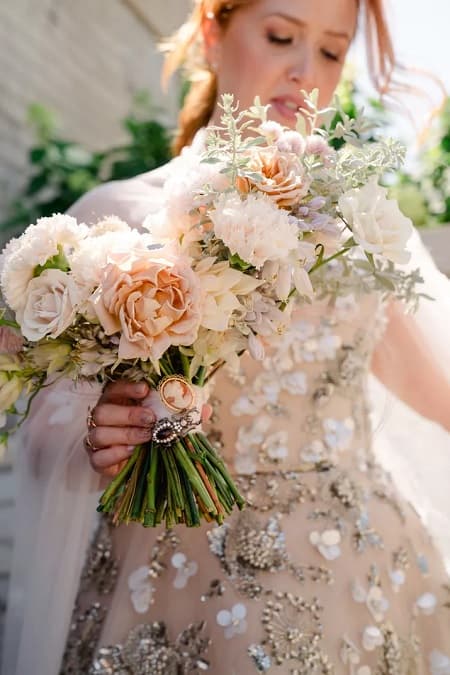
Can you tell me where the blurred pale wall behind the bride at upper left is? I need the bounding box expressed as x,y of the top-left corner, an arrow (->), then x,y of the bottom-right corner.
0,0 -> 189,220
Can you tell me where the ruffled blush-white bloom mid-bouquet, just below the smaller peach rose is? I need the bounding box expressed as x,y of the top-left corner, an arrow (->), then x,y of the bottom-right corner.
210,192 -> 298,269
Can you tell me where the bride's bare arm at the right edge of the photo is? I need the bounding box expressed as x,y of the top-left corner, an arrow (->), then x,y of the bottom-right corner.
372,302 -> 450,431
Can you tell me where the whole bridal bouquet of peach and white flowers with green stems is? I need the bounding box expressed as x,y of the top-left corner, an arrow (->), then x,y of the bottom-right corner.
0,93 -> 420,527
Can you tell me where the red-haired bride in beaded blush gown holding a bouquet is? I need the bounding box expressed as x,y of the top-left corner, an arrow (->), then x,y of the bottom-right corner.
2,0 -> 450,675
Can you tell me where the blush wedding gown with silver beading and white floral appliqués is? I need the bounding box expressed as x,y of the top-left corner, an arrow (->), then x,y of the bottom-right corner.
2,154 -> 450,675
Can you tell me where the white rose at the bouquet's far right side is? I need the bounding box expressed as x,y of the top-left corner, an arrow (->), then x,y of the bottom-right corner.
339,177 -> 413,263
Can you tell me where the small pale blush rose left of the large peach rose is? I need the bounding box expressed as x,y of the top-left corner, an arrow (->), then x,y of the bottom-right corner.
16,269 -> 87,341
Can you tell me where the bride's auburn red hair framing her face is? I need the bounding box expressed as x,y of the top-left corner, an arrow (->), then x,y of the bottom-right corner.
162,0 -> 396,154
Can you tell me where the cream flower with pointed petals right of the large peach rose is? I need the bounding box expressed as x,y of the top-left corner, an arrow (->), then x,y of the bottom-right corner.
195,258 -> 261,332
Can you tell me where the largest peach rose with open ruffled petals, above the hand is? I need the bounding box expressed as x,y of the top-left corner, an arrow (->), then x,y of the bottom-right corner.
91,251 -> 201,363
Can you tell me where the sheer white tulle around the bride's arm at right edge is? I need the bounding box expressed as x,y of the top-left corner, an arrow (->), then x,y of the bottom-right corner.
370,227 -> 450,570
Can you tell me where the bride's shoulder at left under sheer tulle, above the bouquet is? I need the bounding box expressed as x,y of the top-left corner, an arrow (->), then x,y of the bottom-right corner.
68,162 -> 170,227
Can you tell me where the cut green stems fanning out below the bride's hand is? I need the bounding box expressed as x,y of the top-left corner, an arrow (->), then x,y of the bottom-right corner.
97,418 -> 245,528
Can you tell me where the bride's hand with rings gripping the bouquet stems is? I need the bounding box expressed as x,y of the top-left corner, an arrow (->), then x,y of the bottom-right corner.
84,381 -> 155,477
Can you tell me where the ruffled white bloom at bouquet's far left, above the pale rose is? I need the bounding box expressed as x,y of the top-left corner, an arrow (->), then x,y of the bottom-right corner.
0,214 -> 88,311
